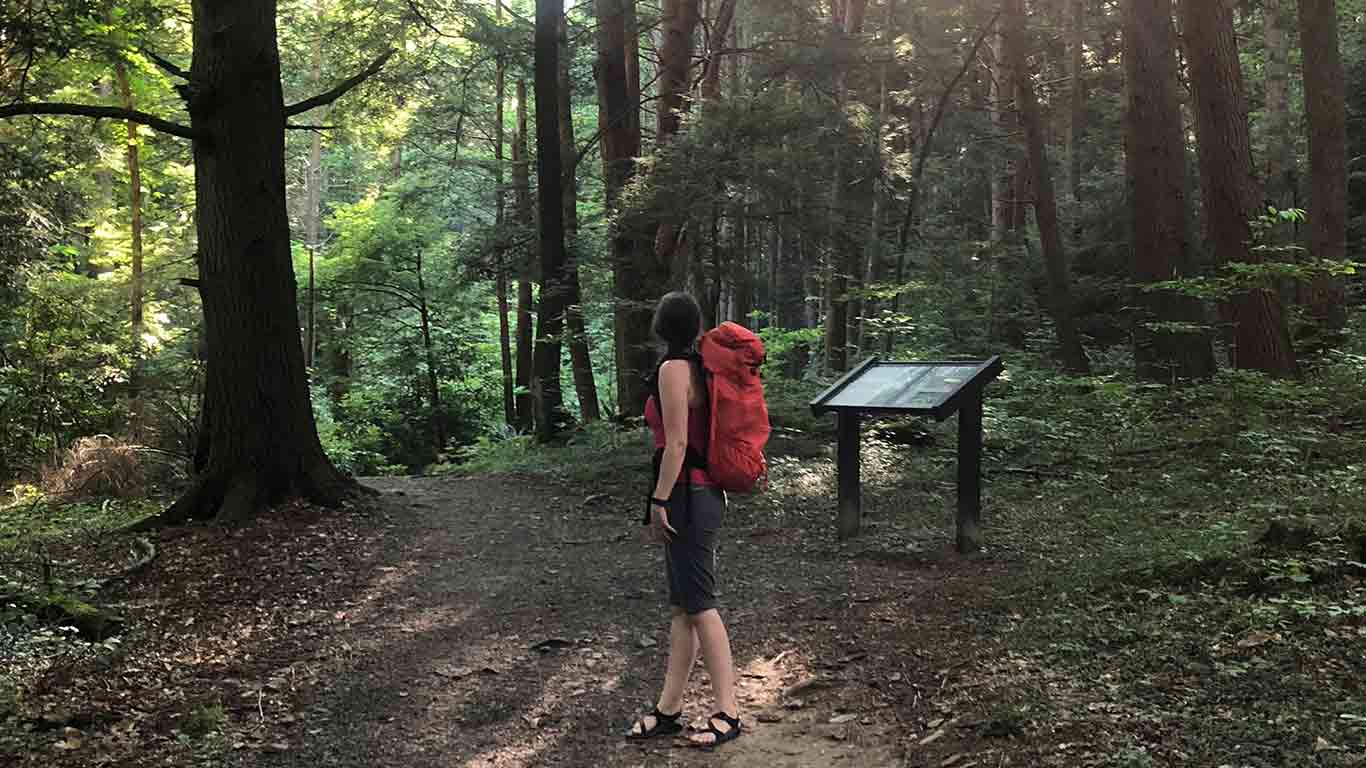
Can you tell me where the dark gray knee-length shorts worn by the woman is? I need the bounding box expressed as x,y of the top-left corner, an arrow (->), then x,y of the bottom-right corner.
664,485 -> 725,615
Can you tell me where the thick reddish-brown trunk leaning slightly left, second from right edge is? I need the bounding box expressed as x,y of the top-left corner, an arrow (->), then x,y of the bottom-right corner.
1180,0 -> 1298,376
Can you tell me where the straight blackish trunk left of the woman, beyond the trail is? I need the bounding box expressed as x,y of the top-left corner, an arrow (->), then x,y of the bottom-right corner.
535,0 -> 570,441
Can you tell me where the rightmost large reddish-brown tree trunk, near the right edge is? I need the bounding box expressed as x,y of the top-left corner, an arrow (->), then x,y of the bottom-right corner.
1299,0 -> 1348,331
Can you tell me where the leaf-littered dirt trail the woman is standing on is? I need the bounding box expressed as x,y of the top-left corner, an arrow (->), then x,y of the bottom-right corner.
224,478 -> 988,768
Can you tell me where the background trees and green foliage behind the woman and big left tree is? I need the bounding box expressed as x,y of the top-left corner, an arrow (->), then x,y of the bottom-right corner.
0,0 -> 1366,484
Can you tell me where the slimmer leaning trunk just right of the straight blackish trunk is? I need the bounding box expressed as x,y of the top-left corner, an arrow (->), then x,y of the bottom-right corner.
557,10 -> 602,422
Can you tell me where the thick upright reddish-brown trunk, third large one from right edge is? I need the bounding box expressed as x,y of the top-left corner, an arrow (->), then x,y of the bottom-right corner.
1124,0 -> 1214,381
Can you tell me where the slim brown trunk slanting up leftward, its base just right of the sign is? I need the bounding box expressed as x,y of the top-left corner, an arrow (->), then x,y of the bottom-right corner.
1005,0 -> 1090,373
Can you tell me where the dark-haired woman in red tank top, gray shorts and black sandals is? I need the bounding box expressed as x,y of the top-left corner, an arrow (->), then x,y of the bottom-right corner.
627,292 -> 740,746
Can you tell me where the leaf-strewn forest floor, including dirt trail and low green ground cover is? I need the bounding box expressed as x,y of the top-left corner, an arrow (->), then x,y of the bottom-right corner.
0,358 -> 1366,768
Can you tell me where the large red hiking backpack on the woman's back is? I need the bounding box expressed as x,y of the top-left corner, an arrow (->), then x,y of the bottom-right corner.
699,323 -> 769,493
